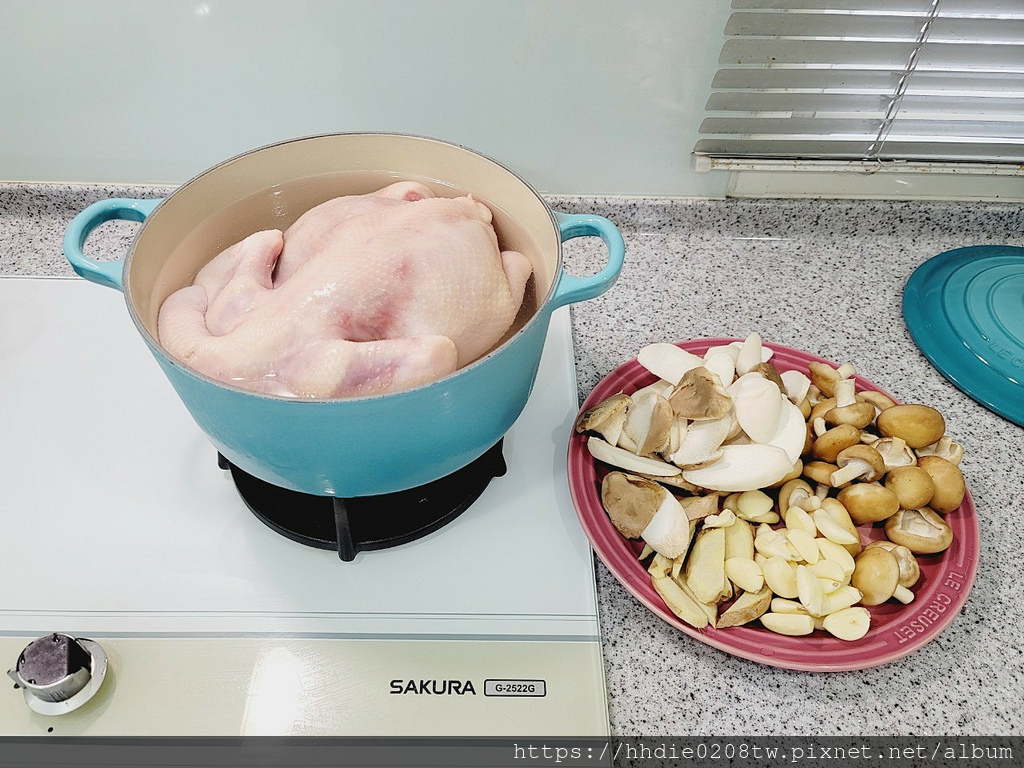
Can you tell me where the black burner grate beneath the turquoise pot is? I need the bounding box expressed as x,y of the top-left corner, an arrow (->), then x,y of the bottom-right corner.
217,441 -> 505,562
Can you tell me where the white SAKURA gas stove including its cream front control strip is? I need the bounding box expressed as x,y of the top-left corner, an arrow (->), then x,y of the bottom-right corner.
0,278 -> 608,736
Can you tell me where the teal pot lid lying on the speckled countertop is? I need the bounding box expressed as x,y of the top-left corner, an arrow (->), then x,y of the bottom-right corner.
903,246 -> 1024,425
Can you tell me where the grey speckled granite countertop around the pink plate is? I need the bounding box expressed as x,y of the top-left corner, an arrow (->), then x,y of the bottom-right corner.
0,184 -> 1024,735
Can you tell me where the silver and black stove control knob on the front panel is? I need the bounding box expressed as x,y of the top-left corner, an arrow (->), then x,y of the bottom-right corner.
7,632 -> 106,715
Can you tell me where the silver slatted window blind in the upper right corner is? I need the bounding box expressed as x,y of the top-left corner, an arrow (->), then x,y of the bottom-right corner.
694,0 -> 1024,172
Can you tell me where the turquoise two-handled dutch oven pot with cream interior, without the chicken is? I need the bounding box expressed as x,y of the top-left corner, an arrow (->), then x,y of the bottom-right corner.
65,133 -> 625,498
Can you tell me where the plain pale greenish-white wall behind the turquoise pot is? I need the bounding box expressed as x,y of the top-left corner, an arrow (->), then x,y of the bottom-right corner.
0,0 -> 729,197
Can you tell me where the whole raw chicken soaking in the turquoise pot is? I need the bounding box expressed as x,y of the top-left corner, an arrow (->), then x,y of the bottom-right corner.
158,181 -> 532,397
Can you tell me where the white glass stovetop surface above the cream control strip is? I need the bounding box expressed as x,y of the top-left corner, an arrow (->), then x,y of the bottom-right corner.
0,278 -> 598,639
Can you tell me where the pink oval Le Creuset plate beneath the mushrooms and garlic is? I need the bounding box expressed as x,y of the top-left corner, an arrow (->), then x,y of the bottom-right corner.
568,339 -> 981,672
